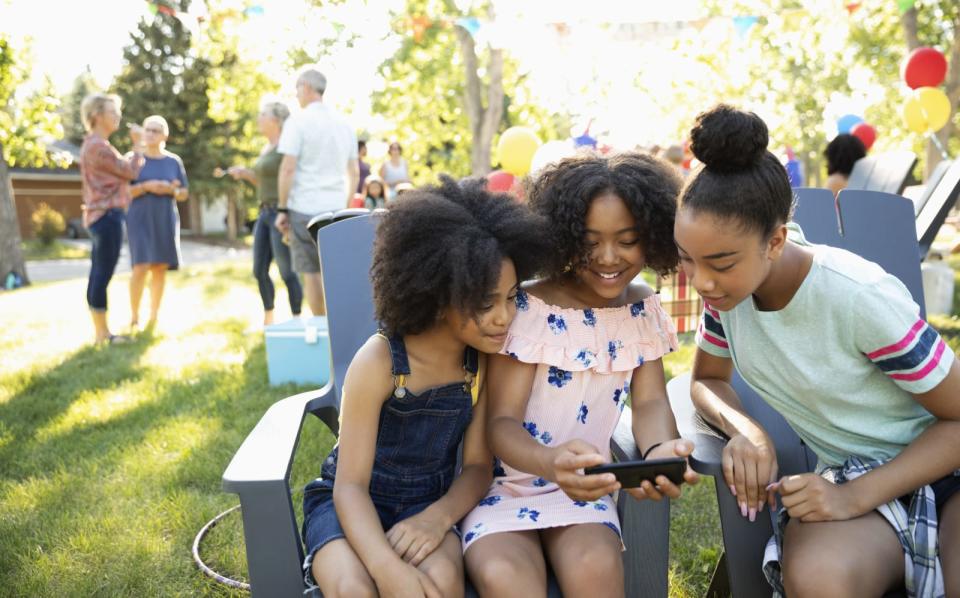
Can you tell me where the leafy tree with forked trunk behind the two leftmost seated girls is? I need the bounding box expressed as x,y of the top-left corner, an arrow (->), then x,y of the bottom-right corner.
373,0 -> 567,182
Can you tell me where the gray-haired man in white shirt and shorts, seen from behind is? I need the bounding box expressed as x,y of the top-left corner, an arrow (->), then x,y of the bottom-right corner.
276,68 -> 360,316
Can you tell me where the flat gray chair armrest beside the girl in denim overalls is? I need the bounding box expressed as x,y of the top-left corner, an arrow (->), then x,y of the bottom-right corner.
223,383 -> 336,494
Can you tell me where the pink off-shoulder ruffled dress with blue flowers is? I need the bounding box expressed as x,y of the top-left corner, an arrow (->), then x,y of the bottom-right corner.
461,291 -> 677,551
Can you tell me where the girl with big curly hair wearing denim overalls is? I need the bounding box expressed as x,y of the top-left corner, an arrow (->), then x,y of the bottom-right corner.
303,177 -> 546,598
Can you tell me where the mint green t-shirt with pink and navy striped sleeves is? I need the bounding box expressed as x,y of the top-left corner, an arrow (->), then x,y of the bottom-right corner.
696,225 -> 954,466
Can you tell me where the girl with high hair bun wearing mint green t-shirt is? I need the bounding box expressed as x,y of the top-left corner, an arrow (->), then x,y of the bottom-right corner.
675,105 -> 960,598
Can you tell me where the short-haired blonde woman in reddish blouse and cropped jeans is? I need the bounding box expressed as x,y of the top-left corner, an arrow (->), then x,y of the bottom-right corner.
80,93 -> 144,343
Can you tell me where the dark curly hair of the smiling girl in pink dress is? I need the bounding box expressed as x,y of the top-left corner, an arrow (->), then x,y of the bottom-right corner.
527,152 -> 681,277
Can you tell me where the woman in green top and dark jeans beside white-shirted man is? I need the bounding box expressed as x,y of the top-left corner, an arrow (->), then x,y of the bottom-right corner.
227,102 -> 303,326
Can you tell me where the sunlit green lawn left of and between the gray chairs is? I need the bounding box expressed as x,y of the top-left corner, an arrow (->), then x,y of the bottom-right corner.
0,263 -> 720,597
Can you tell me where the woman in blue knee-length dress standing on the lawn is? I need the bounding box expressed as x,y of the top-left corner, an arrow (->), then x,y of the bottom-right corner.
127,115 -> 189,330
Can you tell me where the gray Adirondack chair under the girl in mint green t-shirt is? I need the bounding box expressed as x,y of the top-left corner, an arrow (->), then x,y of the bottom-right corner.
667,189 -> 924,598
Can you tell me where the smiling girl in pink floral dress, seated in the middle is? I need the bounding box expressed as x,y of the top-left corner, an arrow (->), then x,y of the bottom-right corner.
461,153 -> 696,597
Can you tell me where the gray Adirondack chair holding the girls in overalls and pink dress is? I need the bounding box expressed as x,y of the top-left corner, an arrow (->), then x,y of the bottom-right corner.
223,209 -> 670,598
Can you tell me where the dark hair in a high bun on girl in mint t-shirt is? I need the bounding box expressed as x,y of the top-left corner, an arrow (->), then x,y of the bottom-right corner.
680,104 -> 793,238
